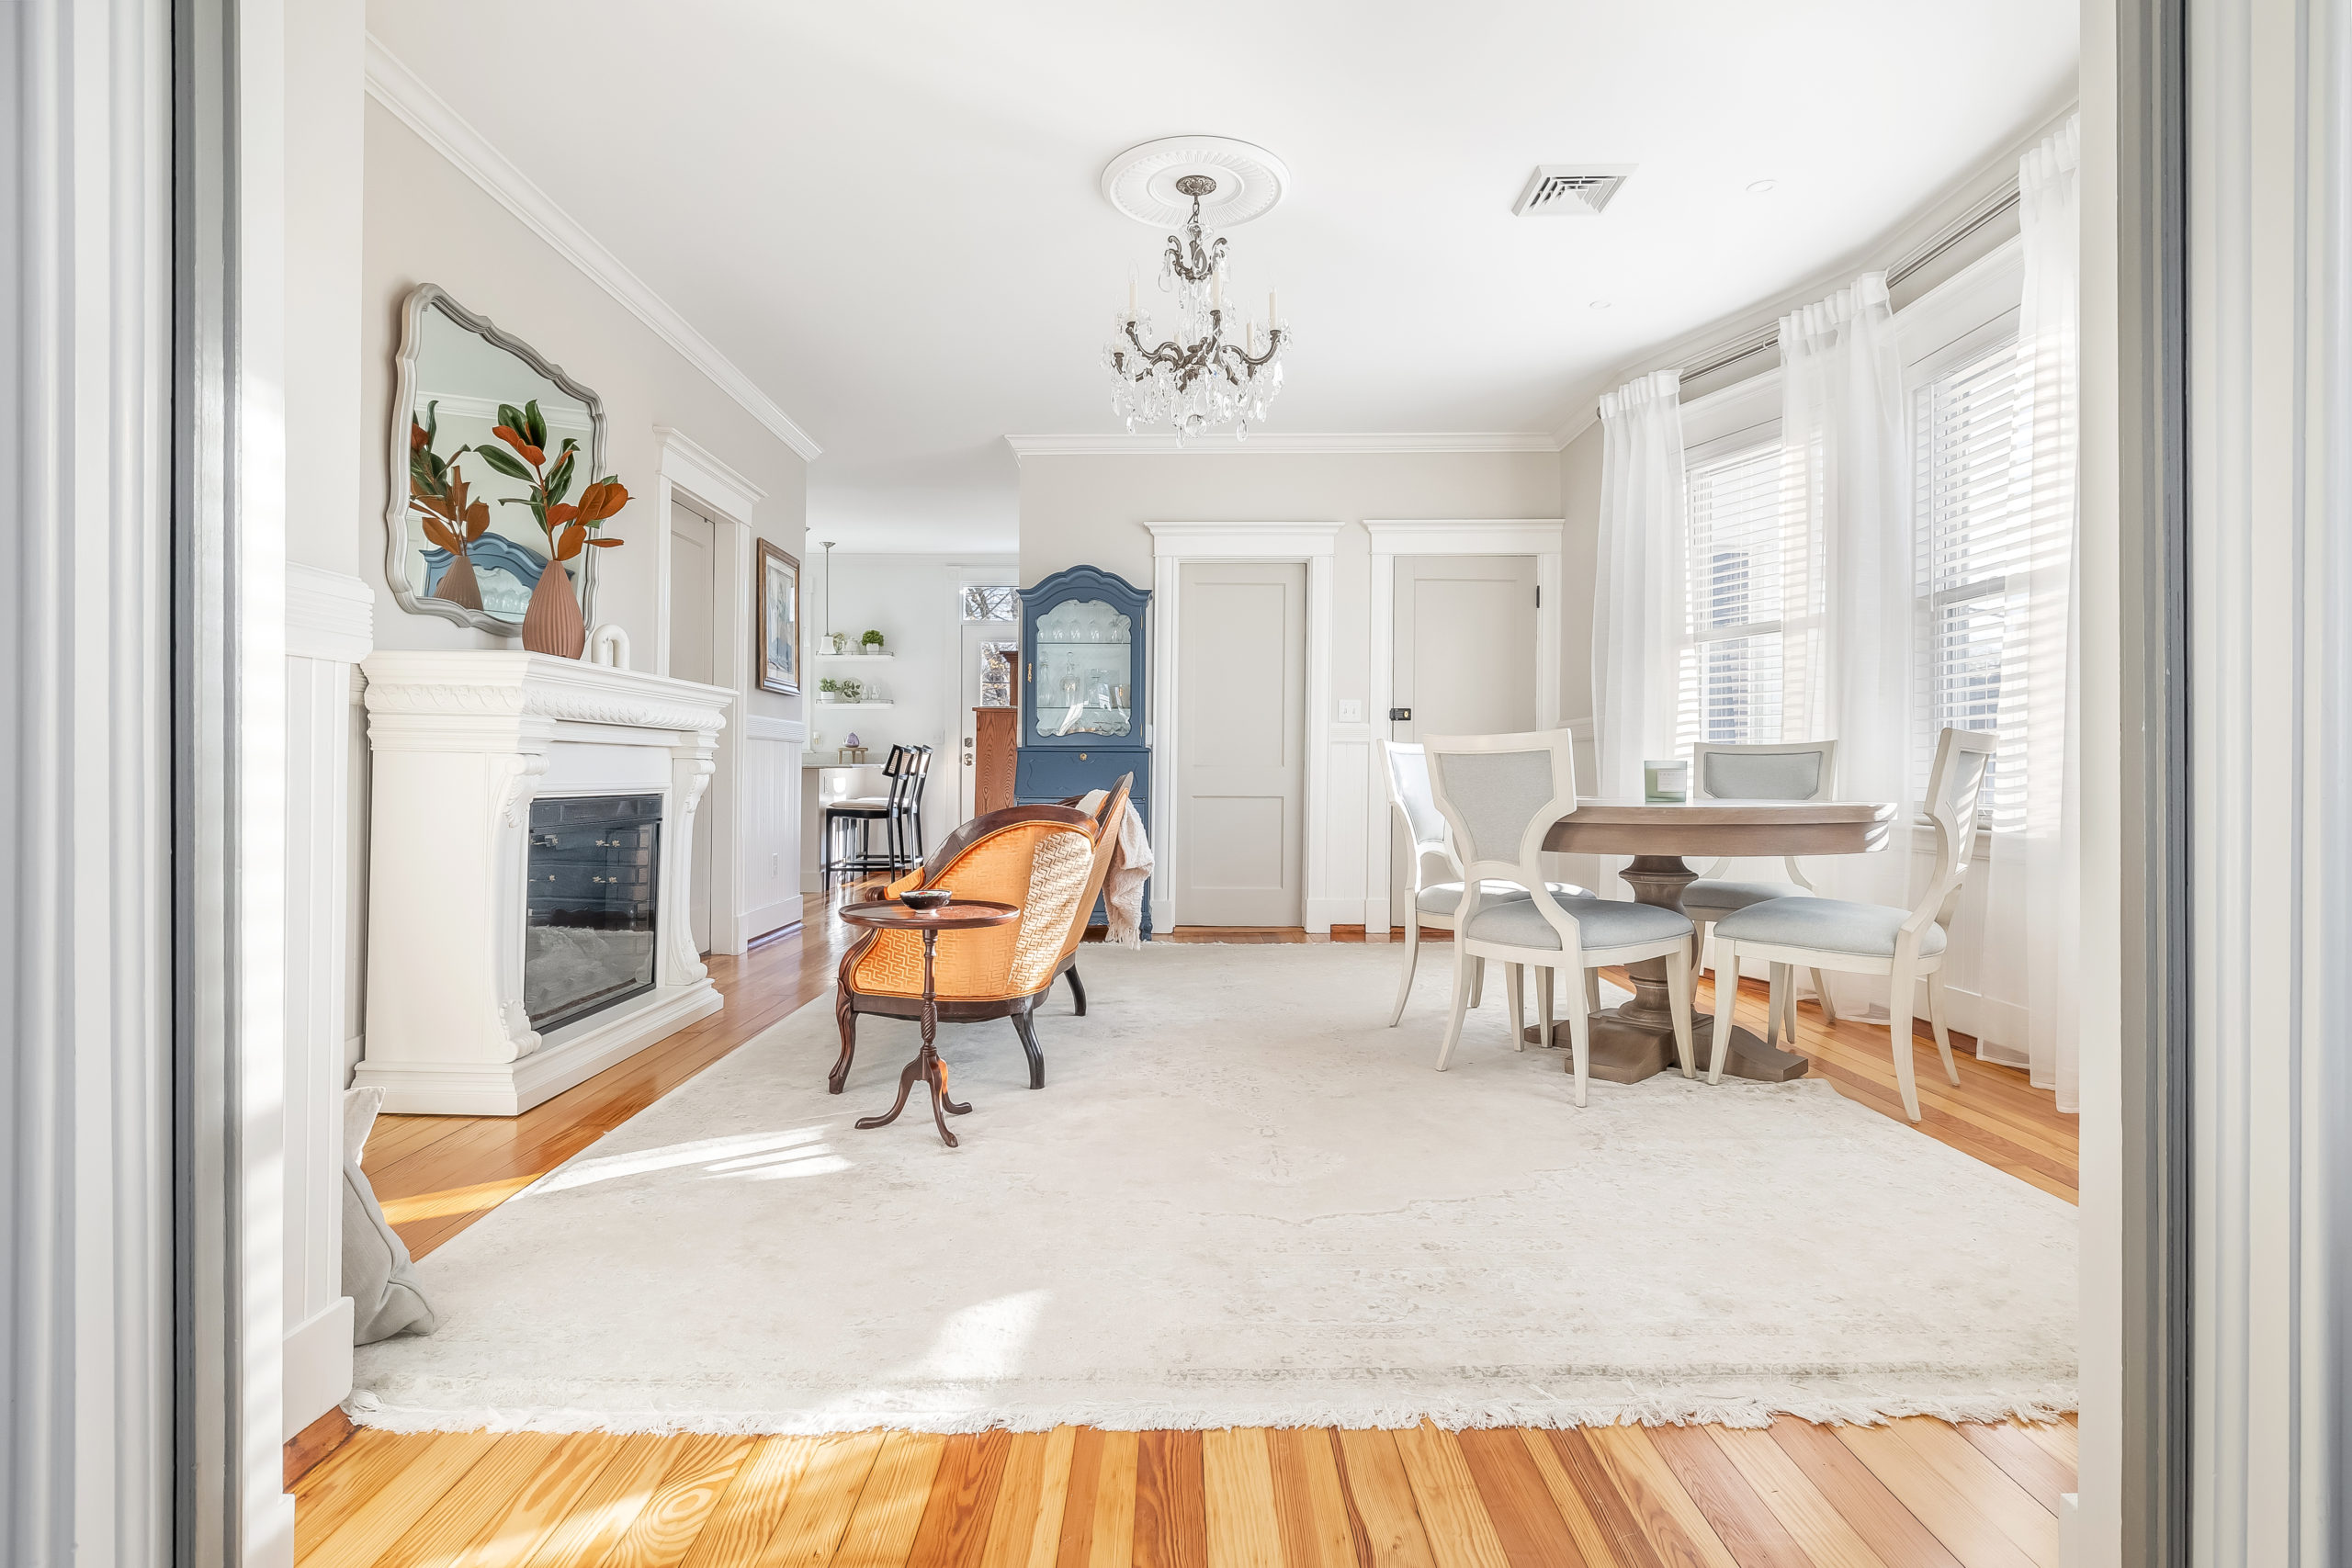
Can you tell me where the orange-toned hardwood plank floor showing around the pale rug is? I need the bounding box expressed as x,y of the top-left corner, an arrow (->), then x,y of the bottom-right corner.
326,900 -> 2076,1568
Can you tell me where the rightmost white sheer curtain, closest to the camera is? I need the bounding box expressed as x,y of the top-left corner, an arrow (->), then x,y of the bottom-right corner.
1978,120 -> 2082,1112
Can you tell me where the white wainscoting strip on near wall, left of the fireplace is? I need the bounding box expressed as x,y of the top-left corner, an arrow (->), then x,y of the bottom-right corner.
285,564 -> 377,1437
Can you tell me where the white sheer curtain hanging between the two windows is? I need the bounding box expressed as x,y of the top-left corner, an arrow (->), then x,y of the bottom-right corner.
1781,273 -> 1917,1016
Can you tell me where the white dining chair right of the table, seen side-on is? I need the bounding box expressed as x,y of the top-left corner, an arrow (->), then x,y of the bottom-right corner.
1708,728 -> 1996,1122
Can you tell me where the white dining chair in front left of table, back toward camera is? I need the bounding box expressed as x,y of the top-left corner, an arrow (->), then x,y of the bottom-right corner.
1423,728 -> 1696,1105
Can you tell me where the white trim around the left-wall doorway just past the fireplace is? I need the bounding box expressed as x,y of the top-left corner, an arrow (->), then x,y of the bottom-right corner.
651,425 -> 767,952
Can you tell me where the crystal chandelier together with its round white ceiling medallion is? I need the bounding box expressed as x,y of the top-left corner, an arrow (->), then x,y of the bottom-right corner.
1103,136 -> 1291,445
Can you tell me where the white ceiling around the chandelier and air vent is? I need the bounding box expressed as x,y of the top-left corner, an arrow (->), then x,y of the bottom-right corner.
369,0 -> 2075,550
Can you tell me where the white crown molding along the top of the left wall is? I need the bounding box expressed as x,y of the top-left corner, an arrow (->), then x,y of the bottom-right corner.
367,33 -> 823,463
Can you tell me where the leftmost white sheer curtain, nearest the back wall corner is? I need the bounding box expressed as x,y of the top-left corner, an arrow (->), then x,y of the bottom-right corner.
1578,369 -> 1691,799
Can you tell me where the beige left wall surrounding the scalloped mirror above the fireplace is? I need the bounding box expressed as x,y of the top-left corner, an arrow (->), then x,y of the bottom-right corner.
357,101 -> 809,717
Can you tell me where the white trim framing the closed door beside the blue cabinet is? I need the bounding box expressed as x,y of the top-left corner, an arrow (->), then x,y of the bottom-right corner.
1143,520 -> 1345,931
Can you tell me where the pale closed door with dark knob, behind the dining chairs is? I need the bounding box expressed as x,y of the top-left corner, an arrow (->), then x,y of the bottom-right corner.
1387,555 -> 1536,919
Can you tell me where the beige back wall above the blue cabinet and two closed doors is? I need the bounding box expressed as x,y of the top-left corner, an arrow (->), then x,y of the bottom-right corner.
1021,451 -> 1571,715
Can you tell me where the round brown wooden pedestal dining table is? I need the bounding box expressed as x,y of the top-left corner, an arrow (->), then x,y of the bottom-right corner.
1536,799 -> 1895,1084
